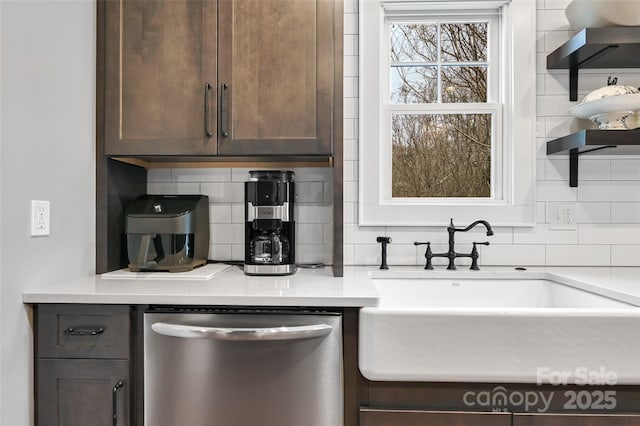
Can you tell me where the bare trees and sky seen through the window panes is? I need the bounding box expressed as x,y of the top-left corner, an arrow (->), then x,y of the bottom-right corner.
390,22 -> 494,198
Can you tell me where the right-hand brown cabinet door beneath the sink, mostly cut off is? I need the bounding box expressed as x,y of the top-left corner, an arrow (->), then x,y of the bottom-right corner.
513,413 -> 640,426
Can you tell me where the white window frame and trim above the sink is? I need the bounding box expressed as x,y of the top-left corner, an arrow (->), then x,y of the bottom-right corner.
358,0 -> 536,226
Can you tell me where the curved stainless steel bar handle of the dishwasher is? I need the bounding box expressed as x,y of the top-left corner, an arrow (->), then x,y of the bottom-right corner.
151,322 -> 333,342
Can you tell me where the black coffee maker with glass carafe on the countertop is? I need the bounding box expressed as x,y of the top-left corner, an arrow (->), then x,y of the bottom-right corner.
244,170 -> 296,275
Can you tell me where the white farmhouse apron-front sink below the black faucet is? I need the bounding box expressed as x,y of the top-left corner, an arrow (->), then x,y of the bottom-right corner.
359,271 -> 640,384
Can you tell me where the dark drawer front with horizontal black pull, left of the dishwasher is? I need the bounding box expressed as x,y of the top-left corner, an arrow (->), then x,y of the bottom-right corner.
36,304 -> 130,359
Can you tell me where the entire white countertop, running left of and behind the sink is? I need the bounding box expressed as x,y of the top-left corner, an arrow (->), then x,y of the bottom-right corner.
22,266 -> 640,307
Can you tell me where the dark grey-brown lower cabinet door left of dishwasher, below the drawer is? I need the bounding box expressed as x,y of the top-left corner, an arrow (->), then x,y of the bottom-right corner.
36,359 -> 130,426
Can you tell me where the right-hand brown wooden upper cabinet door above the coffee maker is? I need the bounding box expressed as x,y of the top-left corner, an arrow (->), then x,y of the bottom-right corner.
218,0 -> 342,155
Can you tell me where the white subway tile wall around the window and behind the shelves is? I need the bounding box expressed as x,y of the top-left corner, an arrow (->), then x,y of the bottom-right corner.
344,0 -> 640,266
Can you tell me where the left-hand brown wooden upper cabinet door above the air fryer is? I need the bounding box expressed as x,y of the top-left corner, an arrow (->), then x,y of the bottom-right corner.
102,0 -> 217,155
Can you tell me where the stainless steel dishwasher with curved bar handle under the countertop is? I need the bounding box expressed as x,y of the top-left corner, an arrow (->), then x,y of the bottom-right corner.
144,307 -> 343,426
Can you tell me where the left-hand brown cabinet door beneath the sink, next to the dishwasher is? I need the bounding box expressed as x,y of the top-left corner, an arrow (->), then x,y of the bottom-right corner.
360,408 -> 511,426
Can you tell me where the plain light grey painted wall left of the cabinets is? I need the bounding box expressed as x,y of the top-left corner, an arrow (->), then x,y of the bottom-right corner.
0,0 -> 96,426
